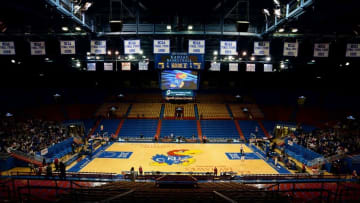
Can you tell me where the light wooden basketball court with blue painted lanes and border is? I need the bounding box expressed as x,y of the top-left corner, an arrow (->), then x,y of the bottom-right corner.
68,143 -> 290,175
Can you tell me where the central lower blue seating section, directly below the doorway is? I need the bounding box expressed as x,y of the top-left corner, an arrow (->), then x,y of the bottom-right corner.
160,120 -> 198,139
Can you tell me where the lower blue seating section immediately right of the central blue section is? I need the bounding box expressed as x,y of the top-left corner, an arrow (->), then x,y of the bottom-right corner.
201,120 -> 240,139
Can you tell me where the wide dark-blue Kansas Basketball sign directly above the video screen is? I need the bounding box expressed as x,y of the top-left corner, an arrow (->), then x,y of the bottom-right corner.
155,53 -> 204,70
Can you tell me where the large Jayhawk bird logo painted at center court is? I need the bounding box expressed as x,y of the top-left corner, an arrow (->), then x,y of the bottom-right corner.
151,149 -> 201,166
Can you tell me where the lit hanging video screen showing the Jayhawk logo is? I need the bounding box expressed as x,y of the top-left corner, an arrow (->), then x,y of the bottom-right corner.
161,70 -> 198,90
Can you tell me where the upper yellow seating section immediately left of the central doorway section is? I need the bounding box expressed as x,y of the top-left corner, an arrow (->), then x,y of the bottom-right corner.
128,103 -> 161,119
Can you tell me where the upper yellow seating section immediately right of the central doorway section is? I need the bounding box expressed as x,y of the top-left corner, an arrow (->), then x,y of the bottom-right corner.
197,104 -> 230,119
